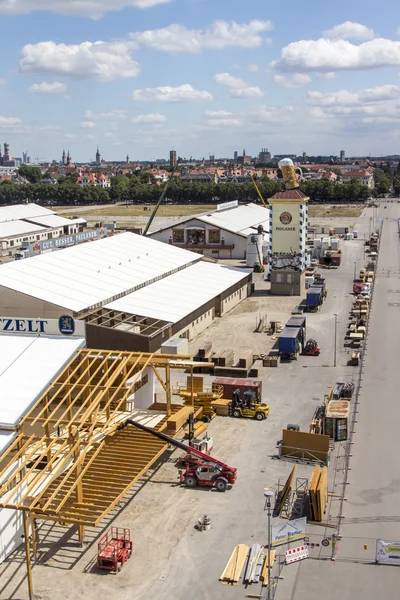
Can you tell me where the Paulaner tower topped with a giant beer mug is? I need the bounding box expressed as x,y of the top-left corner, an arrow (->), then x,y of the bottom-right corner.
269,158 -> 309,296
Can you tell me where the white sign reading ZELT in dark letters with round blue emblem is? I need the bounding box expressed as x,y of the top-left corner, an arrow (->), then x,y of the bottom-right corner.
0,315 -> 86,337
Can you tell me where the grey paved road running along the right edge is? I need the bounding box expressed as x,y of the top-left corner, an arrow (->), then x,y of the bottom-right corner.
277,202 -> 400,600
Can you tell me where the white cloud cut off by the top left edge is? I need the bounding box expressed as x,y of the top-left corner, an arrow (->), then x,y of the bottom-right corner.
0,0 -> 173,19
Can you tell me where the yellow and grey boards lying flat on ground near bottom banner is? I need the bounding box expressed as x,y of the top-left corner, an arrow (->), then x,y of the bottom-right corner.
219,544 -> 276,585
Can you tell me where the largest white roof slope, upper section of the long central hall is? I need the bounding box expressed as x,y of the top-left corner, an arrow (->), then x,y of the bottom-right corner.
0,233 -> 201,312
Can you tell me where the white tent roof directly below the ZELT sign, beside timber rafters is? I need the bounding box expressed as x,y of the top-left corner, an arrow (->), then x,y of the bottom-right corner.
0,334 -> 85,428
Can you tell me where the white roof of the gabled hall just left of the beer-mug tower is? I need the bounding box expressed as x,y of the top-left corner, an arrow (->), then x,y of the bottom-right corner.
194,204 -> 269,236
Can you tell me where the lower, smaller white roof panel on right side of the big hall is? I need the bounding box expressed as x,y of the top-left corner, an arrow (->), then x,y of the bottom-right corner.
105,261 -> 250,323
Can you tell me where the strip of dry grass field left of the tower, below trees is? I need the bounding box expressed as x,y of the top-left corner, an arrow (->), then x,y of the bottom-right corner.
57,204 -> 216,220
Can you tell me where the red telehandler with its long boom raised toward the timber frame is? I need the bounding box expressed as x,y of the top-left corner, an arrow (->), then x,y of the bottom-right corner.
117,419 -> 237,492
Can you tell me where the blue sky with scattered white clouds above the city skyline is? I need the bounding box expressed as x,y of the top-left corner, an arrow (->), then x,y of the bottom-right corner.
0,0 -> 400,161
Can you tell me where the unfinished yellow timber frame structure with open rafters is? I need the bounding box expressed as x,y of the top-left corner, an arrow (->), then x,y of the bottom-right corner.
0,349 -> 209,598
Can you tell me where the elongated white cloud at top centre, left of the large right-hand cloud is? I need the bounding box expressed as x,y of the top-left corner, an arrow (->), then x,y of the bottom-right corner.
130,19 -> 272,53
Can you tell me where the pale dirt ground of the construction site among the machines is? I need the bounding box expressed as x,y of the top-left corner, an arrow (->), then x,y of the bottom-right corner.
0,211 -> 368,600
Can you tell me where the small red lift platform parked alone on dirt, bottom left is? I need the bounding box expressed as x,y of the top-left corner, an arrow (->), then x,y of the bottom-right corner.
97,527 -> 132,572
